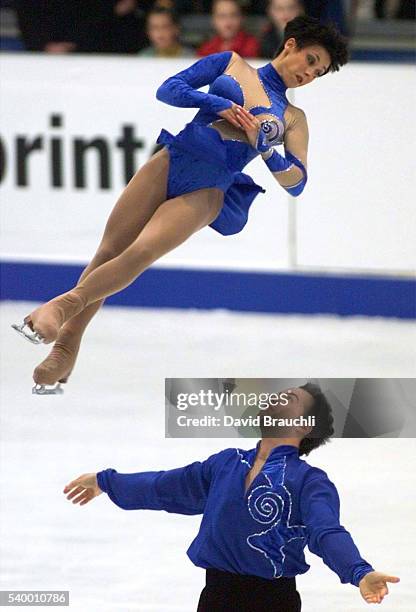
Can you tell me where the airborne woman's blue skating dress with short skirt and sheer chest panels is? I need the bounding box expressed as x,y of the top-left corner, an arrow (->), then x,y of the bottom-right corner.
156,51 -> 303,235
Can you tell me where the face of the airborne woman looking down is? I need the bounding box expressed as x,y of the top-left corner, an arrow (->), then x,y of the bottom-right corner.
279,38 -> 331,87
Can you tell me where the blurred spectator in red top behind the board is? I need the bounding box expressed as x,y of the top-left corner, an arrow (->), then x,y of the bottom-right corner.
198,0 -> 260,57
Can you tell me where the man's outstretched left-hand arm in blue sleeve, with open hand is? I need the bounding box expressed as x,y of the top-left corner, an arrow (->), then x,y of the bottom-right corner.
64,455 -> 216,514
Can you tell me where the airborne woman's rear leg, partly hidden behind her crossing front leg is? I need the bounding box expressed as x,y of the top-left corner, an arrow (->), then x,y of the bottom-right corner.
33,150 -> 169,385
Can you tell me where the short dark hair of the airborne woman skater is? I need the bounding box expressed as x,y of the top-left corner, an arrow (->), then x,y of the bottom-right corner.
276,15 -> 348,72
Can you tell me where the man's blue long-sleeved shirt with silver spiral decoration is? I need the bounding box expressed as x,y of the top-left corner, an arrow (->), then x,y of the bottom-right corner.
97,445 -> 373,586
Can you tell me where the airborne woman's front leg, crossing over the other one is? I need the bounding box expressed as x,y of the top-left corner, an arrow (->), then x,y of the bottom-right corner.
30,188 -> 223,340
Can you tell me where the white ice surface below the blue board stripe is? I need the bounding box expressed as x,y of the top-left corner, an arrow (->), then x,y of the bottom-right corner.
0,302 -> 416,612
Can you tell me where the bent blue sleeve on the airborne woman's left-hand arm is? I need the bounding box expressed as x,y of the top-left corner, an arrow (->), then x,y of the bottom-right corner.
156,51 -> 233,113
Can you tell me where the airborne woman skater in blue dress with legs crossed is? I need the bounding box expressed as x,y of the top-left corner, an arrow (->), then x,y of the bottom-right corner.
13,17 -> 348,392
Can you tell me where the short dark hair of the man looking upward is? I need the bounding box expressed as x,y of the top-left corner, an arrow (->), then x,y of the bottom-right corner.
299,383 -> 334,455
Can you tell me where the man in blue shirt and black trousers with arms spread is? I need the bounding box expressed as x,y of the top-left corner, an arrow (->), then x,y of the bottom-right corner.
64,383 -> 399,612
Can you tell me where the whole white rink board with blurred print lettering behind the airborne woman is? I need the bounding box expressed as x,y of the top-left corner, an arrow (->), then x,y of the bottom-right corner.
0,54 -> 416,272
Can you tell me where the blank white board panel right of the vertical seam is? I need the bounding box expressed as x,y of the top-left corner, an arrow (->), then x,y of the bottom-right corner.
296,64 -> 416,270
